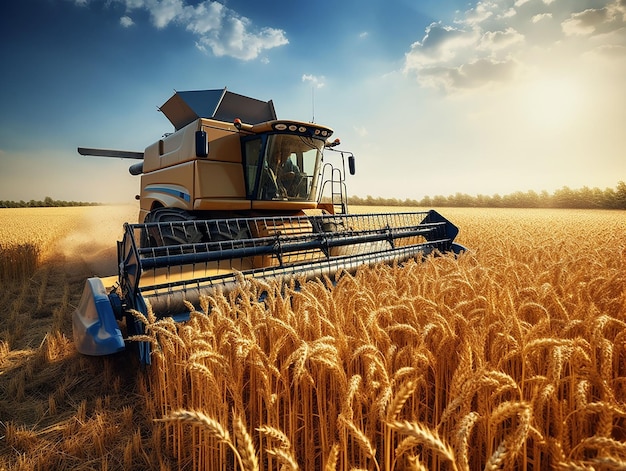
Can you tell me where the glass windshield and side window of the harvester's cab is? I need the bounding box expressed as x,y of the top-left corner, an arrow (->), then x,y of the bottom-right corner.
246,134 -> 324,200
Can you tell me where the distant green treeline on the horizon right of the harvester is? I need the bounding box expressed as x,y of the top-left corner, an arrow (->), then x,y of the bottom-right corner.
349,181 -> 626,209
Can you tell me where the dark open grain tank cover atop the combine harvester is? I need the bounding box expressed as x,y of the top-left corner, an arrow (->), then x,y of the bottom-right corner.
160,88 -> 276,131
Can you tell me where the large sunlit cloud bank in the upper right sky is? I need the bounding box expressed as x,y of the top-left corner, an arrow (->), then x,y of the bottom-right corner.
404,0 -> 626,92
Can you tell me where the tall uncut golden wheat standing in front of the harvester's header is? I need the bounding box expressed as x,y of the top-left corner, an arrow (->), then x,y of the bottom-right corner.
138,211 -> 626,469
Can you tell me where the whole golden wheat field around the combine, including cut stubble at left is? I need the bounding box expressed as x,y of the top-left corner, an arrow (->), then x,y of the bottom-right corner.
0,208 -> 626,470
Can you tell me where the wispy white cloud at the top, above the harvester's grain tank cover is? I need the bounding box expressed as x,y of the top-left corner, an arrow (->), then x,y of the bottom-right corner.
74,0 -> 289,60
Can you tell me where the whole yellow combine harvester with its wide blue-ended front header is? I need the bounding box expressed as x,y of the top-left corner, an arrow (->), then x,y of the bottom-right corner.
73,89 -> 464,363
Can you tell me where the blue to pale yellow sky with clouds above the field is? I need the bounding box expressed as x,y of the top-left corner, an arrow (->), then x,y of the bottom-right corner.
0,0 -> 626,203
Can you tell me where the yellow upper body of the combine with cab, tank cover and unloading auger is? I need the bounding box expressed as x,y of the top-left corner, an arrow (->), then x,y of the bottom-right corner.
78,89 -> 352,227
